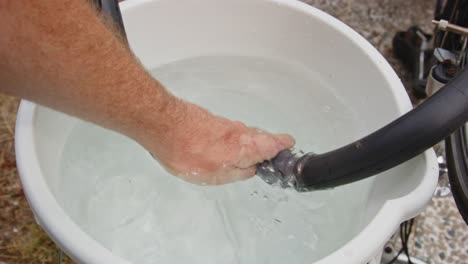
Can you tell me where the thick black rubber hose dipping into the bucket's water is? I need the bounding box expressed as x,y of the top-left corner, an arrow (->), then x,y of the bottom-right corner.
294,70 -> 468,190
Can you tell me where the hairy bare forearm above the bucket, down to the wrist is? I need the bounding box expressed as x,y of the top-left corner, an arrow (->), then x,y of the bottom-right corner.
0,0 -> 176,142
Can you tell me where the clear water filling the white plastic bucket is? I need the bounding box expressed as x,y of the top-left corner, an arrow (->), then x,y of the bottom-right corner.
59,56 -> 370,264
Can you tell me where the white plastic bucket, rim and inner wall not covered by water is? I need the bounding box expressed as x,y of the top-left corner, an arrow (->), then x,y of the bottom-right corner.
16,0 -> 438,263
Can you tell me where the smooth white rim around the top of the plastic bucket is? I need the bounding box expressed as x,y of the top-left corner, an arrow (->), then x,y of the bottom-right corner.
15,0 -> 438,264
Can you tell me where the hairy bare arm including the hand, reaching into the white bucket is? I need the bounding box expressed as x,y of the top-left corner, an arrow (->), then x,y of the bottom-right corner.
0,0 -> 294,184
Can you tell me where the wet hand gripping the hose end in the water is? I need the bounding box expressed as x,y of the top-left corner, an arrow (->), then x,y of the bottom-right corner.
143,99 -> 294,185
